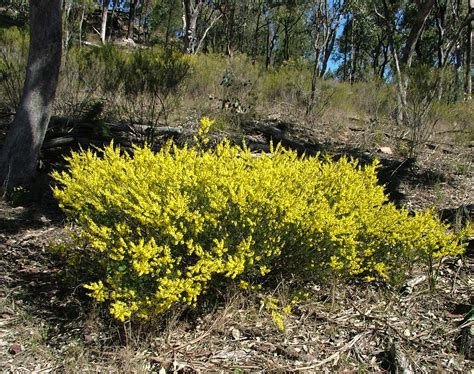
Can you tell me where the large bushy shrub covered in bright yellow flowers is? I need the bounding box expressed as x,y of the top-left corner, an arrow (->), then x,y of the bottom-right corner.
53,119 -> 463,321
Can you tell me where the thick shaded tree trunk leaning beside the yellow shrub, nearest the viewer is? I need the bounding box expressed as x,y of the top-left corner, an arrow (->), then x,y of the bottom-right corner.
0,0 -> 62,189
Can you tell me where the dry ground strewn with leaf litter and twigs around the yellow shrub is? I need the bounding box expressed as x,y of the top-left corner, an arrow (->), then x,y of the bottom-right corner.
0,116 -> 474,373
